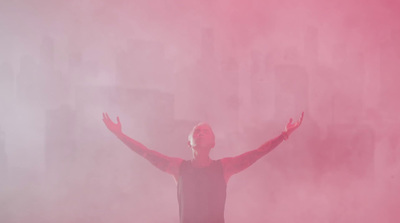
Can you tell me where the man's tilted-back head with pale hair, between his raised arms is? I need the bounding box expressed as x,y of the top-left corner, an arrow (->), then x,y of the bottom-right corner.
188,122 -> 215,151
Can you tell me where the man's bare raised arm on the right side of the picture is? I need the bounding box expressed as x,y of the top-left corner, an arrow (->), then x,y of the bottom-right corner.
221,112 -> 304,182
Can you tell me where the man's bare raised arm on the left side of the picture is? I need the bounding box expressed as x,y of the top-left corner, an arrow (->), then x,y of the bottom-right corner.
103,113 -> 183,179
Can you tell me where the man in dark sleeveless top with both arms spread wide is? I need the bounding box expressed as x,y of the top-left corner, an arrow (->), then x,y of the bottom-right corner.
103,113 -> 304,223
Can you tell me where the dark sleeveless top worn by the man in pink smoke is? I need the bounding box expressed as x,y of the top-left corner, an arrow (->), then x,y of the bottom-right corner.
178,160 -> 226,223
